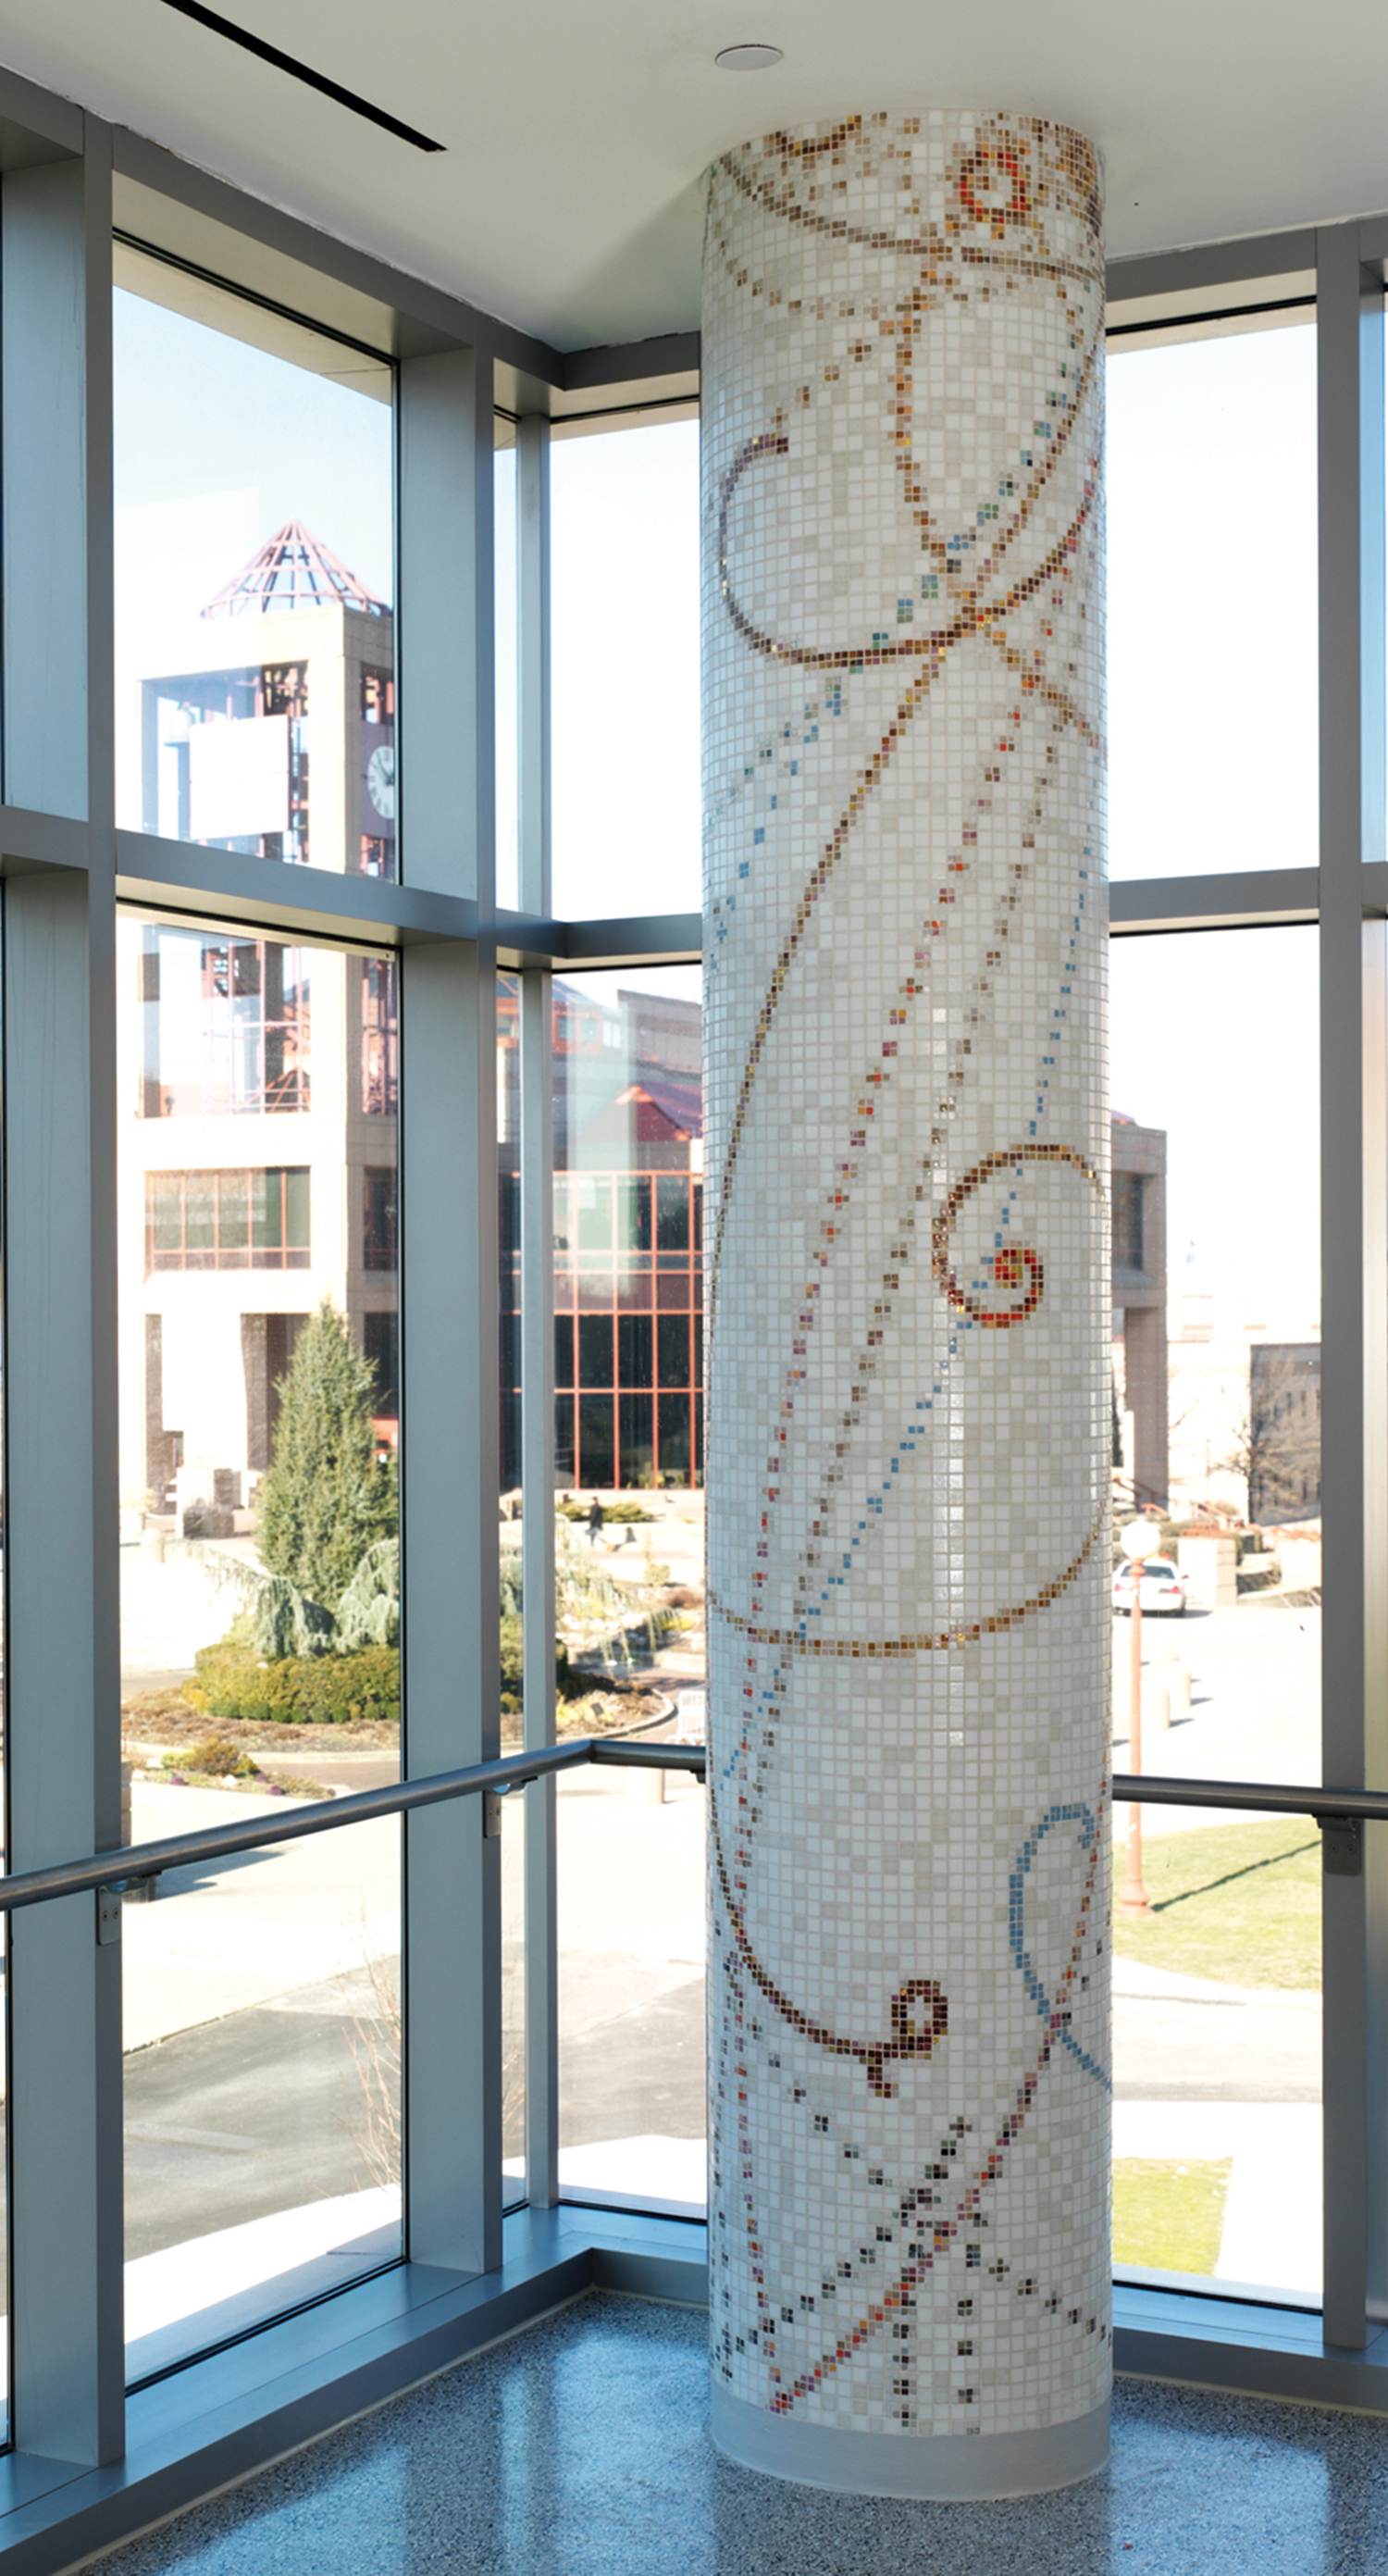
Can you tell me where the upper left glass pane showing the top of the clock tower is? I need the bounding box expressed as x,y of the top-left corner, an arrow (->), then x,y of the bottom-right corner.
113,244 -> 399,880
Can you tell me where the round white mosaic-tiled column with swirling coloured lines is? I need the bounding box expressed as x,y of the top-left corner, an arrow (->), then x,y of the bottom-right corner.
703,113 -> 1109,2496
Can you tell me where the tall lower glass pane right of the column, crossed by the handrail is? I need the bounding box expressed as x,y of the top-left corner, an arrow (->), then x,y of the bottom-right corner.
1112,930 -> 1321,2303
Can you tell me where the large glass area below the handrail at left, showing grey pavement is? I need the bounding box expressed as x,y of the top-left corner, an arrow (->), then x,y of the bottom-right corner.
121,1823 -> 402,2380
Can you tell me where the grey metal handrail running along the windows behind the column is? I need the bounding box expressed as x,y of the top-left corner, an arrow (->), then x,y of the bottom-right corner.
0,1736 -> 1388,1914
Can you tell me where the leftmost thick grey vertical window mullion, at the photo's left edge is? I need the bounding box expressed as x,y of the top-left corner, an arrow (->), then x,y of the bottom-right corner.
0,118 -> 124,2463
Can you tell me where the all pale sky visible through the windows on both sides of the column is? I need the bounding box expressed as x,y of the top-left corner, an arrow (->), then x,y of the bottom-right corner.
116,279 -> 1319,1337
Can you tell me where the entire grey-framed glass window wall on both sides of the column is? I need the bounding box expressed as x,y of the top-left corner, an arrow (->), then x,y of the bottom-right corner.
0,70 -> 1388,2545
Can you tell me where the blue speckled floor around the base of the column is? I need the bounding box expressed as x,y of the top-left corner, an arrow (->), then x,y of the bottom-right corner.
101,2297 -> 1388,2576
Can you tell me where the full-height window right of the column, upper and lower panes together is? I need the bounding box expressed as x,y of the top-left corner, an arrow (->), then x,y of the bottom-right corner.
1108,304 -> 1323,2303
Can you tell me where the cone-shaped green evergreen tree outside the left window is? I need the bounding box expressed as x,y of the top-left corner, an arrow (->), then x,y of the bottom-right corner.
257,1299 -> 399,1610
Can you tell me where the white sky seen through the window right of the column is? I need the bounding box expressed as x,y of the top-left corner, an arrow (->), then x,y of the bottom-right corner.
1108,325 -> 1321,1339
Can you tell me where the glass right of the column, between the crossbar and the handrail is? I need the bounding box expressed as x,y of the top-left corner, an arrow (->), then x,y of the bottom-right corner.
1112,930 -> 1321,1780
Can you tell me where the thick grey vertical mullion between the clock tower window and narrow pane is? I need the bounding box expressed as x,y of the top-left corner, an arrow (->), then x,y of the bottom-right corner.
399,350 -> 502,2274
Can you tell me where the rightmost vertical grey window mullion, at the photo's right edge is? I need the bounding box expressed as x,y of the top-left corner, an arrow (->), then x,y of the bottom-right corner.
1316,224 -> 1388,2346
